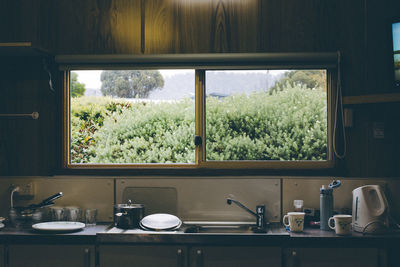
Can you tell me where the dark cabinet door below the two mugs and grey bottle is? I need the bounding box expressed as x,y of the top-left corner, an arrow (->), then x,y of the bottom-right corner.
285,248 -> 380,267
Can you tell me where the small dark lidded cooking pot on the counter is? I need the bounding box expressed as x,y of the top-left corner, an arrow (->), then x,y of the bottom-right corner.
114,200 -> 144,229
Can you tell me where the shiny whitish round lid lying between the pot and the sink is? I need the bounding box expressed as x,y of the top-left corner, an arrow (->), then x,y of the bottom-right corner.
140,213 -> 182,231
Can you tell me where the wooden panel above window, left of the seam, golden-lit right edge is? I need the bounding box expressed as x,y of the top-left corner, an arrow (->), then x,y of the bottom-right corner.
56,0 -> 141,54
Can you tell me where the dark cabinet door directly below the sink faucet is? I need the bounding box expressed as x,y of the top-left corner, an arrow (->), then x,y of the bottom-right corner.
190,246 -> 281,267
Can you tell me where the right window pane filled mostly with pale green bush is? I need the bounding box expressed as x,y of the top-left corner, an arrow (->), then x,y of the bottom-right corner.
206,70 -> 328,161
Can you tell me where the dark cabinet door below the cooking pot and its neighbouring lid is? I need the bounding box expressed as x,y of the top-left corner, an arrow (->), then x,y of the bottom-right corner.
99,245 -> 187,267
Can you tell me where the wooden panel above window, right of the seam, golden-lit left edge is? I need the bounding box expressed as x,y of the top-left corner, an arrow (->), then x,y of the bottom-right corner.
145,0 -> 259,54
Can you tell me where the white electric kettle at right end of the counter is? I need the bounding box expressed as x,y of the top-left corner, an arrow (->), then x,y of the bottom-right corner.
352,185 -> 389,233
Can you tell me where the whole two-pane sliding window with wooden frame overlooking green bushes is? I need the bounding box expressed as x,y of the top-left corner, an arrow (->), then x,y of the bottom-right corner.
61,53 -> 336,169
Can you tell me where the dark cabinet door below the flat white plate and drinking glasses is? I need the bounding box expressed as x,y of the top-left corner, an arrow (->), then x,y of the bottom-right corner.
8,245 -> 95,267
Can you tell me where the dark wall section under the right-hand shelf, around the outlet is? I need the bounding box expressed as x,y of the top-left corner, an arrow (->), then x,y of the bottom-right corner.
345,103 -> 400,177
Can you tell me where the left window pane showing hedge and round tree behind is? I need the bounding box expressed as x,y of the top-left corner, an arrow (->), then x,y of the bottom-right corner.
70,70 -> 195,164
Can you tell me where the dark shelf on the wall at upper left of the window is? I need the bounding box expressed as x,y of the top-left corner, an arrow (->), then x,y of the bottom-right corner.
0,42 -> 49,57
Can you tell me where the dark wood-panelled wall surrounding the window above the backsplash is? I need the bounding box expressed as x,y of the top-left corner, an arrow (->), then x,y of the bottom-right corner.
0,0 -> 400,177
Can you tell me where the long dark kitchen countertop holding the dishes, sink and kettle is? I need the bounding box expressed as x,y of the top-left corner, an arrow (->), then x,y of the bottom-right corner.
0,225 -> 400,247
